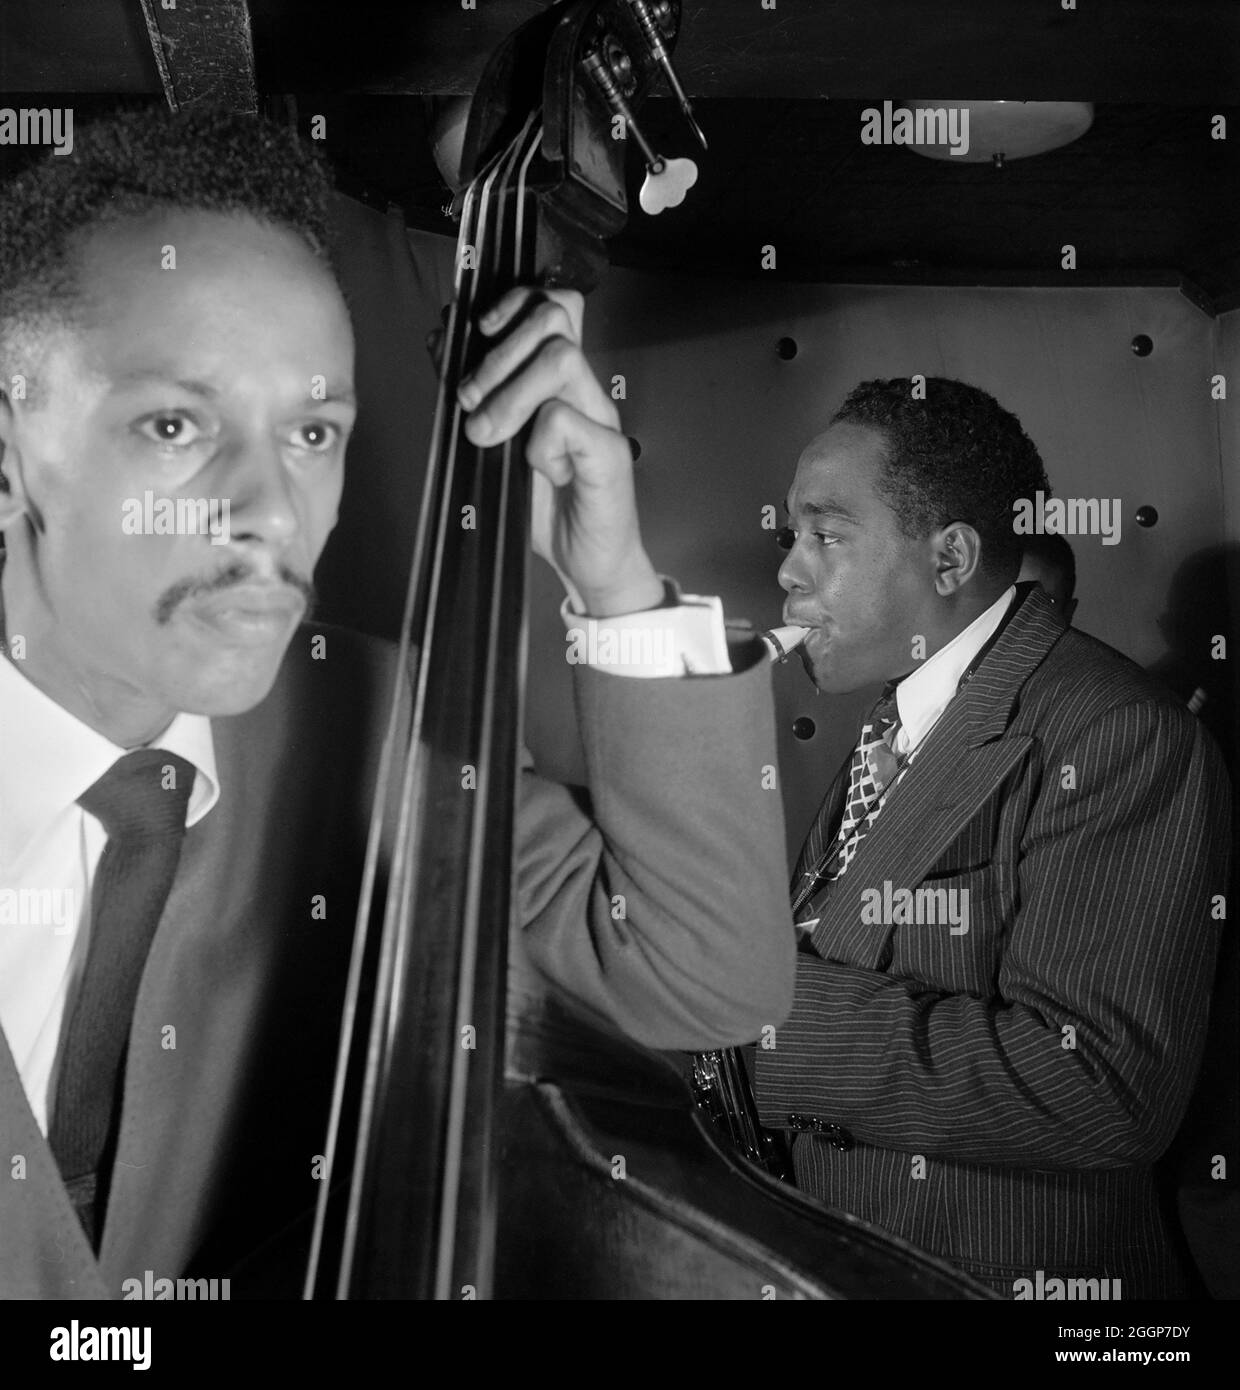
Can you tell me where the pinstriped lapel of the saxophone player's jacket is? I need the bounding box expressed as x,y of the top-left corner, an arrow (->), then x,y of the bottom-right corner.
806,589 -> 1063,969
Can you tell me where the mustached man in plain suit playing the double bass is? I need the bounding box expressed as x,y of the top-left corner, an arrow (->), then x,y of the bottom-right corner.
0,113 -> 792,1298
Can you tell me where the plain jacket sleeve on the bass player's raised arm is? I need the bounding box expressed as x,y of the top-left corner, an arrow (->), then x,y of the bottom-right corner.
517,636 -> 794,1049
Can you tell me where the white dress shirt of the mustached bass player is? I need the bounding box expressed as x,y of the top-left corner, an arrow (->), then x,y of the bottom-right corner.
0,657 -> 220,1134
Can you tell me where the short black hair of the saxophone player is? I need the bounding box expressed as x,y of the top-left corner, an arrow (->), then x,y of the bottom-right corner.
831,377 -> 1051,582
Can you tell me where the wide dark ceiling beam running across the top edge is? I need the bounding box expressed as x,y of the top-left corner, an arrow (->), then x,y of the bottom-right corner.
0,0 -> 1240,106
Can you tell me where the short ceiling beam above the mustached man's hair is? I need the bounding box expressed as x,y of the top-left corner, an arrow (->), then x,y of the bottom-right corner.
139,0 -> 259,113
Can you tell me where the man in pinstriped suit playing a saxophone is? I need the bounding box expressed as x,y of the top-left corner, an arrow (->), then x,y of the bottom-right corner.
756,378 -> 1230,1298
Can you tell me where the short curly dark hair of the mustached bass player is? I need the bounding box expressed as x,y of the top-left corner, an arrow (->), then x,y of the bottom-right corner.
0,107 -> 332,386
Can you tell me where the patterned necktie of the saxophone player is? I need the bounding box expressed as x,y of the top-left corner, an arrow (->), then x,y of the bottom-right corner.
792,677 -> 904,908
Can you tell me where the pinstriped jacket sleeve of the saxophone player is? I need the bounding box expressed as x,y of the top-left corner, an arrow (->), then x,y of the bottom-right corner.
759,701 -> 1229,1168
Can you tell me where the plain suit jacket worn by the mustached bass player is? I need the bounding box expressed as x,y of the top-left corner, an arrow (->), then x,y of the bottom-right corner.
0,628 -> 794,1298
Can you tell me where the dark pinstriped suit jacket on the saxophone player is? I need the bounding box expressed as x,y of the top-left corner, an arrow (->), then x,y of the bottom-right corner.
756,585 -> 1230,1298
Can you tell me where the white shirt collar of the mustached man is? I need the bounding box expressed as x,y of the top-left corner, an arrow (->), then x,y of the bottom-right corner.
0,656 -> 220,865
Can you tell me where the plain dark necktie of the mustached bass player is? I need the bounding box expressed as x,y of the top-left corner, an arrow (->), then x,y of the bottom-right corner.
47,748 -> 195,1250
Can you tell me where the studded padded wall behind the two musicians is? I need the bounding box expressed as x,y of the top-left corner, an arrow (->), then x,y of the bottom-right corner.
320,203 -> 1240,847
